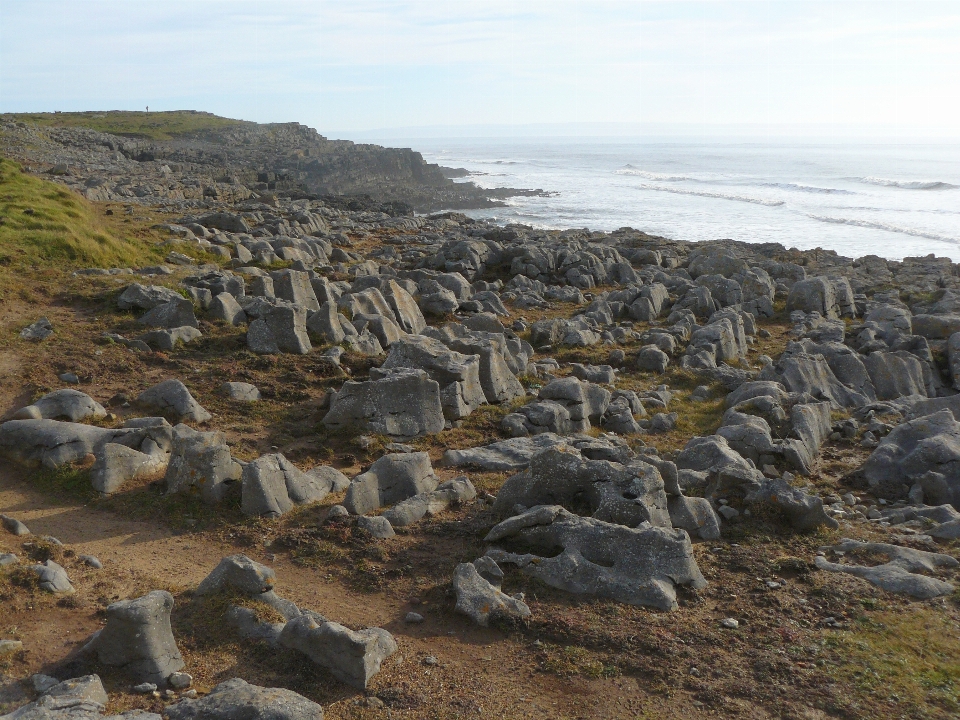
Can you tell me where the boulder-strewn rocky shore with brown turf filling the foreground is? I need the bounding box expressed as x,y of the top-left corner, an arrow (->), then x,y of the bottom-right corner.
0,114 -> 960,720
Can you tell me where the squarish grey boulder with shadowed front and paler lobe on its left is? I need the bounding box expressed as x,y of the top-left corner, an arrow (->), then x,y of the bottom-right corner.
343,452 -> 438,515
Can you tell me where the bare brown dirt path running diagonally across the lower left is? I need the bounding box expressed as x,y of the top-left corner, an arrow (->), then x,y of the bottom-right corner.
0,467 -> 724,718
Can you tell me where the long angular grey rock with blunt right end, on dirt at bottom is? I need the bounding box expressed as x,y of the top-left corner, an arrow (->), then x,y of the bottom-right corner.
280,615 -> 397,689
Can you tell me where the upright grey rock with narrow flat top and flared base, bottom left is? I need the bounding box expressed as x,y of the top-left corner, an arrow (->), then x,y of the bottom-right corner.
82,590 -> 184,685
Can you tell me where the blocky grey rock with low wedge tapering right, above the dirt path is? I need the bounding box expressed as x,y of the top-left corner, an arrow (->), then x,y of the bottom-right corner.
241,453 -> 329,517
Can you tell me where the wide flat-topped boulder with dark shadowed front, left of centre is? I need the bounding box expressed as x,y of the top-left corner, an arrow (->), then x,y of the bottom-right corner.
323,369 -> 444,438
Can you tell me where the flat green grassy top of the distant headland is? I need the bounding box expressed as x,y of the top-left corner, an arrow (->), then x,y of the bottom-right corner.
3,110 -> 248,140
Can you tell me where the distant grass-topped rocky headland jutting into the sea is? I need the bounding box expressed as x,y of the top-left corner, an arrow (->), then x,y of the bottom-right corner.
0,113 -> 532,211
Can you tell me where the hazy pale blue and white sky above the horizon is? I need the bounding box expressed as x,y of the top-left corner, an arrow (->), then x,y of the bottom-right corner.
0,0 -> 960,136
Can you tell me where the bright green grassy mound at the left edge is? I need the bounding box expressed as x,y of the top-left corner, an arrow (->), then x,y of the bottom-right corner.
0,159 -> 155,272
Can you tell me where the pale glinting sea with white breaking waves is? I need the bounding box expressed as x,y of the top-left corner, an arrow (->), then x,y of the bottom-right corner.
402,138 -> 960,261
